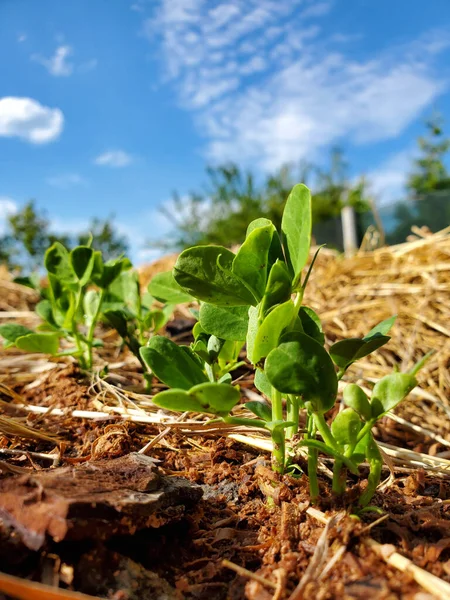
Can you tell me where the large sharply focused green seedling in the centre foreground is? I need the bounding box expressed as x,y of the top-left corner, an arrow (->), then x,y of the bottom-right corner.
141,184 -> 427,506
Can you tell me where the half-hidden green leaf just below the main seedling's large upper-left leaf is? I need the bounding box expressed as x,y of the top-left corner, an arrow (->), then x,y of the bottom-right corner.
200,302 -> 249,342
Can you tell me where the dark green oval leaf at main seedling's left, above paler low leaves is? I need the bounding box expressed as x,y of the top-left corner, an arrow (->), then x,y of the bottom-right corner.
140,336 -> 207,390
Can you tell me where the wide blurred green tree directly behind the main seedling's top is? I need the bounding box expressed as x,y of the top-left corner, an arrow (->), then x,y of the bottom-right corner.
151,149 -> 369,250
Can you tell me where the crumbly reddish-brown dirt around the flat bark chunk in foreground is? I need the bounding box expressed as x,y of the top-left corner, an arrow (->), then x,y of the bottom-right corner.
0,366 -> 450,600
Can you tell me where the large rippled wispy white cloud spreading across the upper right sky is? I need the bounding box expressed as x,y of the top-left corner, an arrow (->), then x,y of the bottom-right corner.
144,0 -> 447,169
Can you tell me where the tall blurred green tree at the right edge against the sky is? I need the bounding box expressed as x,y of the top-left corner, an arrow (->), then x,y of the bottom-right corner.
387,114 -> 450,243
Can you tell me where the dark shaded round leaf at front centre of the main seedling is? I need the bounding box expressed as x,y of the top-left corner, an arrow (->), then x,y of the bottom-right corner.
265,332 -> 338,413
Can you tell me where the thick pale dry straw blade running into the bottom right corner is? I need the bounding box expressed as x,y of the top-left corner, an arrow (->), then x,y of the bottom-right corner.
308,508 -> 450,600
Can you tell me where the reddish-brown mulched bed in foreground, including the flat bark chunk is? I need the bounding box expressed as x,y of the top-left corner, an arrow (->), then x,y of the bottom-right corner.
0,356 -> 450,600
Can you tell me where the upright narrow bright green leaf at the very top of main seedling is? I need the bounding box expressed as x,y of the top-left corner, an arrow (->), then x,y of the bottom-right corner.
281,184 -> 312,287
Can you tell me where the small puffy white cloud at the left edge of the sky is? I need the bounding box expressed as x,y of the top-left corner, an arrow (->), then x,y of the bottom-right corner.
0,96 -> 64,144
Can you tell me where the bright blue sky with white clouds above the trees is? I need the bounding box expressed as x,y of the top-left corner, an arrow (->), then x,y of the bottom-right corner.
0,0 -> 450,262
